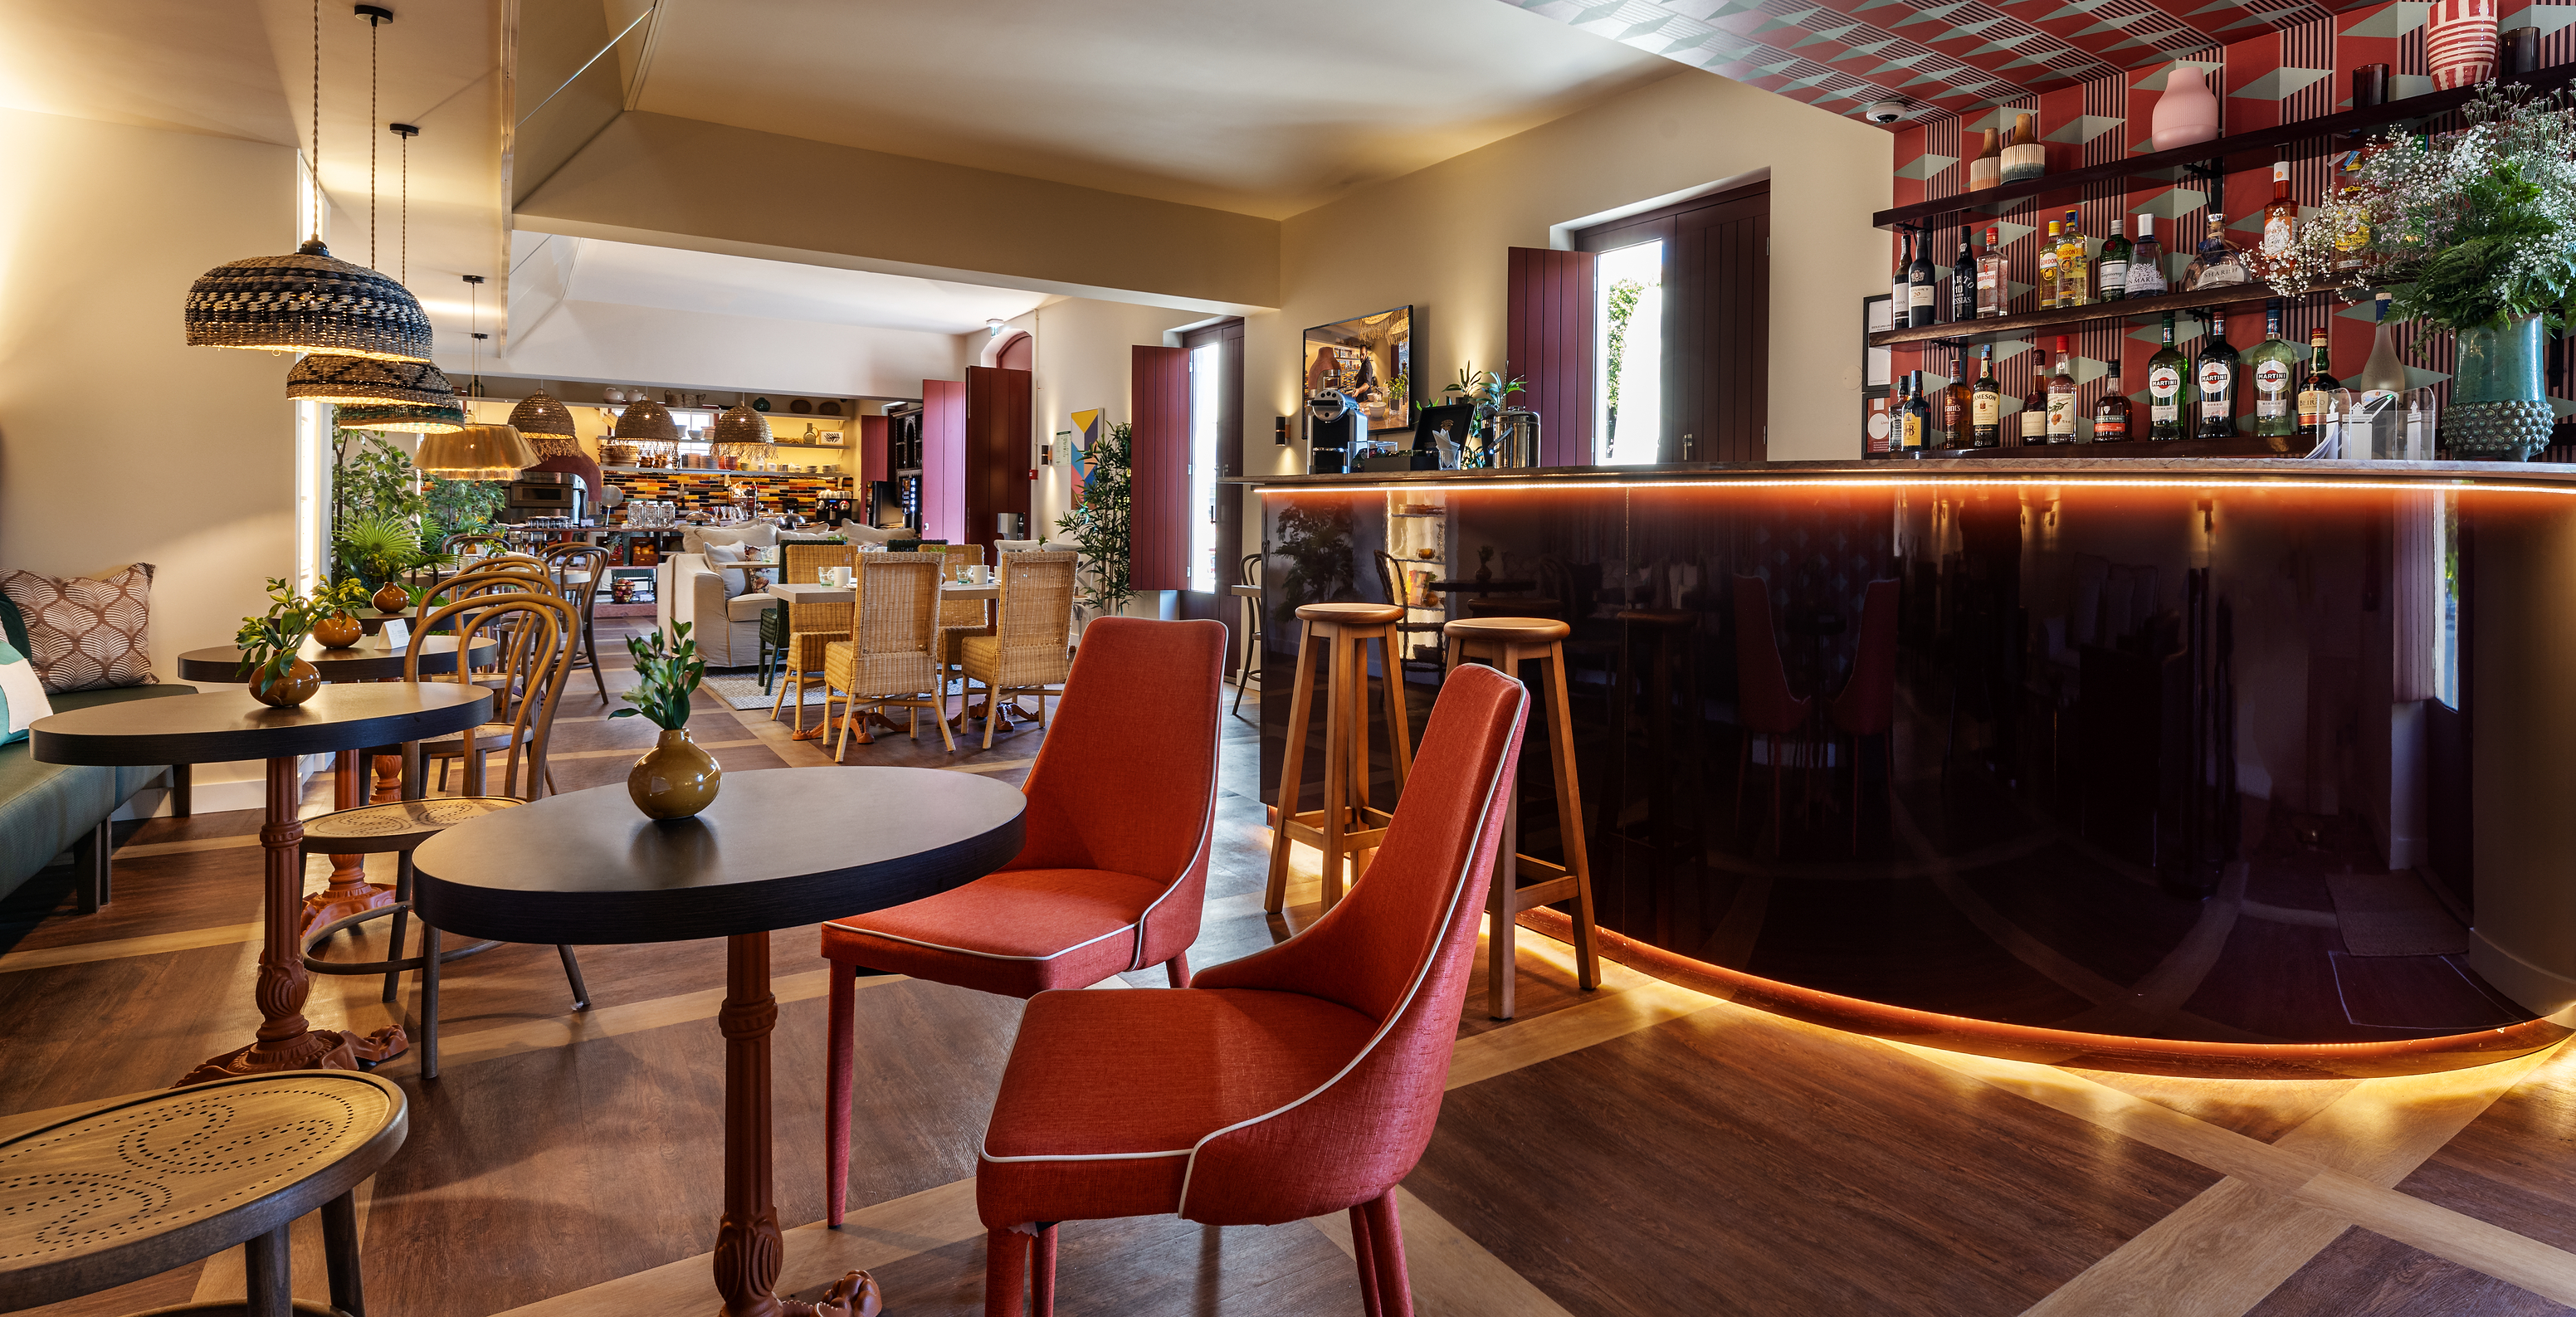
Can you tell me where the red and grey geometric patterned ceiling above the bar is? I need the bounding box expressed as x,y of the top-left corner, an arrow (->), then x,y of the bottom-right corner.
1502,0 -> 2349,124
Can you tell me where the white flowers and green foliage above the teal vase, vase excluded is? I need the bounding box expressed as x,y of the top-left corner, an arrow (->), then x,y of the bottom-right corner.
2261,82 -> 2576,330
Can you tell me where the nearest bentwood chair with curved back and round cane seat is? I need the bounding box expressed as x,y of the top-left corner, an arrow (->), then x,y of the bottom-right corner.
301,593 -> 590,1080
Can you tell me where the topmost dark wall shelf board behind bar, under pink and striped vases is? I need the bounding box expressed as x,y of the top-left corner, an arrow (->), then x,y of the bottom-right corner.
1871,65 -> 2576,229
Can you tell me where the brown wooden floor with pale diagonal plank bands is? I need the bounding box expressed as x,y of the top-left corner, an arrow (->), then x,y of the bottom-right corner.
15,621 -> 2576,1317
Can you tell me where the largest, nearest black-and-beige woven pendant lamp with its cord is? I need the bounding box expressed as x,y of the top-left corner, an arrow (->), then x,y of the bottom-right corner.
185,0 -> 430,361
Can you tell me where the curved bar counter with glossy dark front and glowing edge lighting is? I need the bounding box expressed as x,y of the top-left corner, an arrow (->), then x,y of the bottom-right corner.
1244,459 -> 2576,1077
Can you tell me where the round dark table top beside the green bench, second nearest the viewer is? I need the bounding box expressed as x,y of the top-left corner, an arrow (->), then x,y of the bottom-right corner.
28,680 -> 492,765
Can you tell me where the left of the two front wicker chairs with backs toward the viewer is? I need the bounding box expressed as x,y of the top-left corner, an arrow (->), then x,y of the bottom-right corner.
822,554 -> 959,763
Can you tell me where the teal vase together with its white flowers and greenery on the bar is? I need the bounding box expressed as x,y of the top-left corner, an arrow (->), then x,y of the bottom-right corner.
2270,85 -> 2576,461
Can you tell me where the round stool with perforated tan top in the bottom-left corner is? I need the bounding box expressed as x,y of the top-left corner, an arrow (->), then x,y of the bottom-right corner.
0,1070 -> 410,1317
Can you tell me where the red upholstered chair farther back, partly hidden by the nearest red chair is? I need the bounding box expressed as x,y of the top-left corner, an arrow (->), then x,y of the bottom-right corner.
822,618 -> 1227,1224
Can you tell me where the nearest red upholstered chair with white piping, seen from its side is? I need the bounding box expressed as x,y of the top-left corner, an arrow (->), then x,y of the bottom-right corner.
976,667 -> 1528,1317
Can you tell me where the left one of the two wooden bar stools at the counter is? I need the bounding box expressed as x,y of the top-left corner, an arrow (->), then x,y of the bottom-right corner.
1262,603 -> 1414,915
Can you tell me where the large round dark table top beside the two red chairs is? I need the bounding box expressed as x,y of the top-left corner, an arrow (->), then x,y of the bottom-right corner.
412,768 -> 1025,944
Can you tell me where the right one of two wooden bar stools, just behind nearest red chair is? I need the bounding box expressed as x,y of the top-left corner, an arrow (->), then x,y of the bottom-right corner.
1442,618 -> 1603,1021
